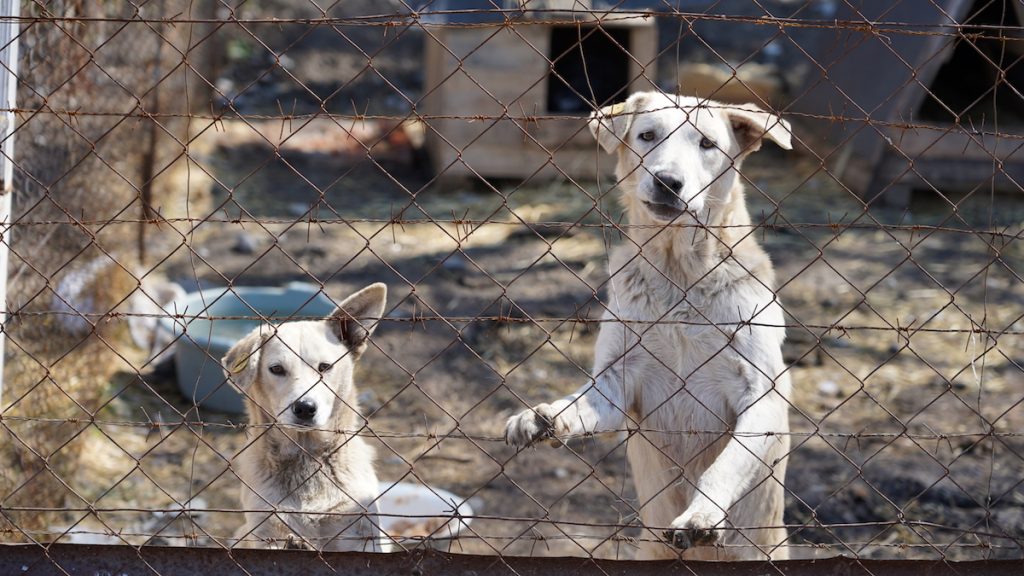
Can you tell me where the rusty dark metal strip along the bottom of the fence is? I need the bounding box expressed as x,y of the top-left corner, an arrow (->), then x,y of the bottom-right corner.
0,544 -> 1024,576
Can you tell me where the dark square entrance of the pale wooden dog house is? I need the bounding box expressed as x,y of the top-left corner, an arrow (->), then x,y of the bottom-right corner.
548,26 -> 630,114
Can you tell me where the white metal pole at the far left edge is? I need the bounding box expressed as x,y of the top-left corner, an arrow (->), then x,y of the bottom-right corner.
0,0 -> 22,405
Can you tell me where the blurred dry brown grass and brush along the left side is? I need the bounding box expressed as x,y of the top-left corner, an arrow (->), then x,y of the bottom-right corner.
0,0 -> 214,539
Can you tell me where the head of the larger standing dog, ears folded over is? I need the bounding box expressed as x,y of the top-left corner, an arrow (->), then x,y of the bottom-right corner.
589,92 -> 792,223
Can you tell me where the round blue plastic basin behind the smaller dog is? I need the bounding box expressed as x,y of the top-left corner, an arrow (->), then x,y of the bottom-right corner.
160,282 -> 335,413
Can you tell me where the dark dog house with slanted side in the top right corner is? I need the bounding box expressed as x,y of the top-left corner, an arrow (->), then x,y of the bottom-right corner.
790,0 -> 1024,205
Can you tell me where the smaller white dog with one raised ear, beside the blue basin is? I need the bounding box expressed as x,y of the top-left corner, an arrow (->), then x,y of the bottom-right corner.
222,284 -> 387,551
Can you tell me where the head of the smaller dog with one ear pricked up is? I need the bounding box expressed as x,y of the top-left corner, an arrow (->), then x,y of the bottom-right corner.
221,284 -> 387,427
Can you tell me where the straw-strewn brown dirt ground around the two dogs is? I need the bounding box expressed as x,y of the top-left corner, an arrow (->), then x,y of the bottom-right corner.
16,1 -> 1024,560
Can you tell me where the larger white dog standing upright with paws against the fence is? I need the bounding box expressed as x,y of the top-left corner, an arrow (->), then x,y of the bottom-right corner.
505,92 -> 791,560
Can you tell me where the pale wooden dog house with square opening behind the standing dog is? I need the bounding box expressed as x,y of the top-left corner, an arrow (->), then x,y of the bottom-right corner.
417,0 -> 657,179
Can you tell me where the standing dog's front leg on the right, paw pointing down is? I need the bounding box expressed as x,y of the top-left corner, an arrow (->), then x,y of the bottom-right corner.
665,387 -> 788,549
